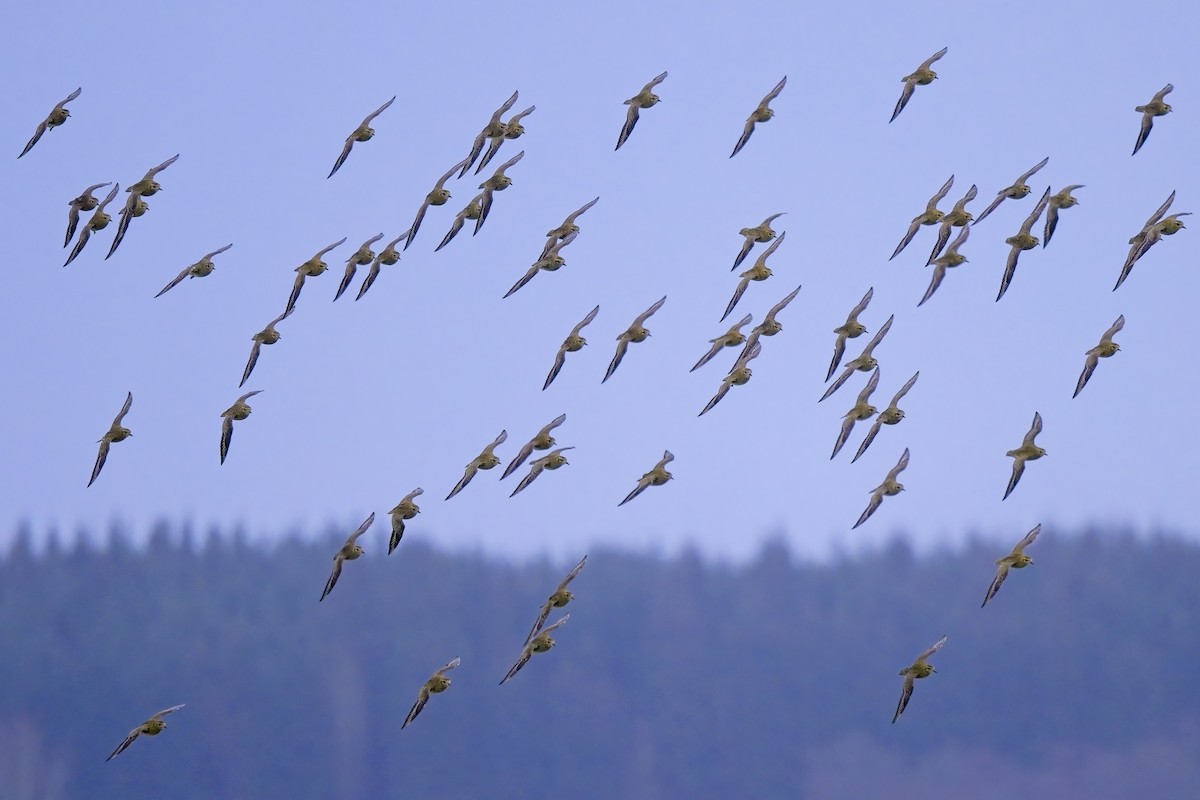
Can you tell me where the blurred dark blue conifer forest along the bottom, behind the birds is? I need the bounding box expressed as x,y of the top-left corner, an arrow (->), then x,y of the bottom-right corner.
0,525 -> 1200,800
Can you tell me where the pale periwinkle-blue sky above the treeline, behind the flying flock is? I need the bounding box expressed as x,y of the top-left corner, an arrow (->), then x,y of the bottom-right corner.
0,1 -> 1200,557
